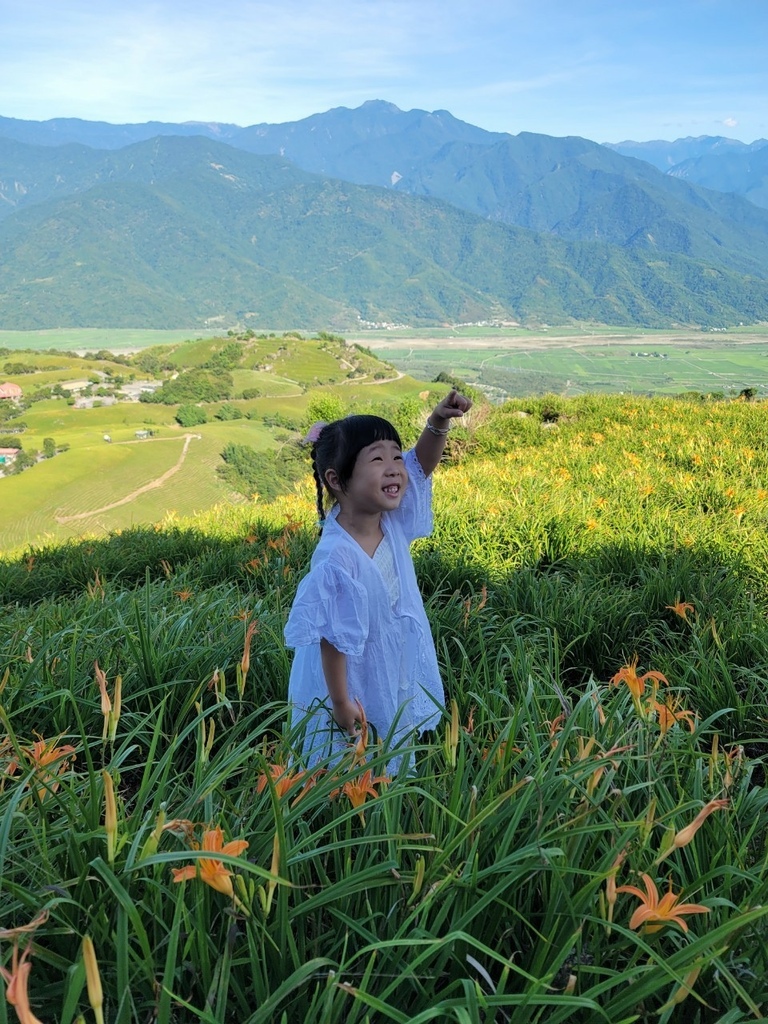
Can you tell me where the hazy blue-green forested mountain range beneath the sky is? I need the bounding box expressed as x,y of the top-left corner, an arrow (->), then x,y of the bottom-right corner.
0,100 -> 768,330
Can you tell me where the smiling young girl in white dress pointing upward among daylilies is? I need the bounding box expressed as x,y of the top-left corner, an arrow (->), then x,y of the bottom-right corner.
285,391 -> 472,766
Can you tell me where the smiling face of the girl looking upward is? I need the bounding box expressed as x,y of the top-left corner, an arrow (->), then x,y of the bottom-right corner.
326,441 -> 408,515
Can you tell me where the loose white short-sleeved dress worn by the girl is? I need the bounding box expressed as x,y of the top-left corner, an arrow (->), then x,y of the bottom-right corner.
285,451 -> 444,766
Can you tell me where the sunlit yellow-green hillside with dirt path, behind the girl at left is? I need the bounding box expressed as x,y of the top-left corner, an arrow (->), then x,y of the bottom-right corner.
0,333 -> 434,553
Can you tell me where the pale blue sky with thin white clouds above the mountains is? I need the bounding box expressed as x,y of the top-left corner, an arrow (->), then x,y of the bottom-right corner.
0,0 -> 768,142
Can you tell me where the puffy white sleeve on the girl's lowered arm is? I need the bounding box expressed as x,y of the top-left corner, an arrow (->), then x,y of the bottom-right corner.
285,561 -> 369,656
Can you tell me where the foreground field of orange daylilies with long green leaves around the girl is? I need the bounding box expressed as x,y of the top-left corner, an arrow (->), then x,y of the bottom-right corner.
0,387 -> 768,1024
